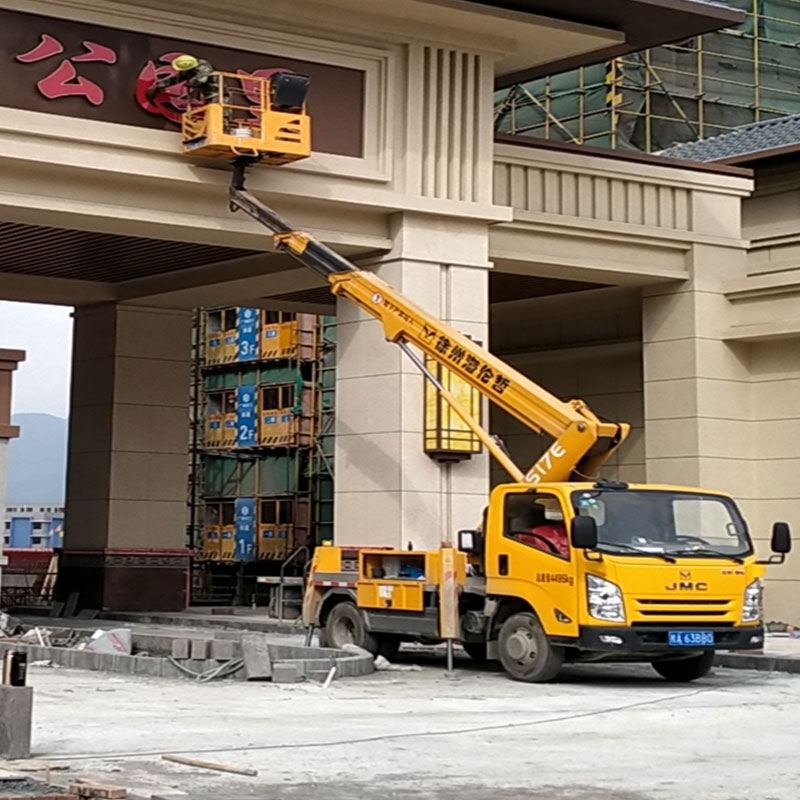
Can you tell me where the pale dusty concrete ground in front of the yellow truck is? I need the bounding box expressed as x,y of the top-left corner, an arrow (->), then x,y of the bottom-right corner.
18,652 -> 800,800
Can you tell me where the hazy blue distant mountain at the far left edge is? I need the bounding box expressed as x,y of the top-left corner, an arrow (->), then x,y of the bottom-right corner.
6,414 -> 67,505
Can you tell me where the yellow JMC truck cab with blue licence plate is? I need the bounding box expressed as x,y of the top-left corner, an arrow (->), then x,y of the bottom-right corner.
460,481 -> 789,680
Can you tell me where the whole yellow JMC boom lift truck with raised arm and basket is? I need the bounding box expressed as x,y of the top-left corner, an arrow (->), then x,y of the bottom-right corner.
177,67 -> 791,682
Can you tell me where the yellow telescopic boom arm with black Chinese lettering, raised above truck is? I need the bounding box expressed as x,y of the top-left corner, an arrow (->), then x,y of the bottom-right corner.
230,159 -> 630,484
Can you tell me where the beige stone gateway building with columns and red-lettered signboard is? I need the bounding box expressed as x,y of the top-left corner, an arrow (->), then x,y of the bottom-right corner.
0,0 -> 800,617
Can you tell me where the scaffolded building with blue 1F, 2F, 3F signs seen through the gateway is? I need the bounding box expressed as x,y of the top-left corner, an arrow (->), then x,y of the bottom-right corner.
189,307 -> 335,605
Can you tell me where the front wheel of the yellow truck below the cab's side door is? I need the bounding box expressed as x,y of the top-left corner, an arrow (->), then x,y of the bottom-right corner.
497,613 -> 564,683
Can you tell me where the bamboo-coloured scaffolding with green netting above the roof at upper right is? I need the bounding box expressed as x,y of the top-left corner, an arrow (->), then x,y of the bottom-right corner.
495,0 -> 800,153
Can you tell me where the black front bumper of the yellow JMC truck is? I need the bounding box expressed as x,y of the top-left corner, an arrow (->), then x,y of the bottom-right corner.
578,622 -> 764,655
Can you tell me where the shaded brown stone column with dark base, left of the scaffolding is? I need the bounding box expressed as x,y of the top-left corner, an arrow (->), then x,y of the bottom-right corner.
58,305 -> 191,611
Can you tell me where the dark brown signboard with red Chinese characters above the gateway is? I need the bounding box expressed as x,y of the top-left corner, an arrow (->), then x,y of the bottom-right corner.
0,9 -> 364,157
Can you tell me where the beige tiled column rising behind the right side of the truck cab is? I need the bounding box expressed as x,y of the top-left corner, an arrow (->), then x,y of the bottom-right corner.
642,245 -> 753,500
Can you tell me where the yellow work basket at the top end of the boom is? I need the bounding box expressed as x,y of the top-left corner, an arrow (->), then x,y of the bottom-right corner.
181,72 -> 311,165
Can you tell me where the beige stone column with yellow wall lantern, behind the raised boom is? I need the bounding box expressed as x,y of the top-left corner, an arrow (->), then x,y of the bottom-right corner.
335,215 -> 490,549
